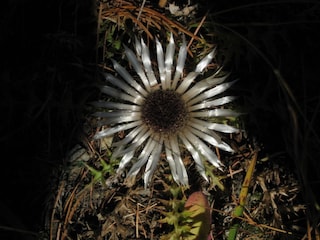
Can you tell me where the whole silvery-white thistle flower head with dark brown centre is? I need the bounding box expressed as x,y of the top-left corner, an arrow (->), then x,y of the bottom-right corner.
94,34 -> 239,187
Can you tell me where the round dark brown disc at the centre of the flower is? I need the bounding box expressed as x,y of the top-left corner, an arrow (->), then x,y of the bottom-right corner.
141,89 -> 188,134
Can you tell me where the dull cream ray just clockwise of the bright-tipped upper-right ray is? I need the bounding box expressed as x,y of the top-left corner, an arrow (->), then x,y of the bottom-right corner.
182,74 -> 229,102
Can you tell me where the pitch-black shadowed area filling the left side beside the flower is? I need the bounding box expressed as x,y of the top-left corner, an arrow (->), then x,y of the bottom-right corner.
0,0 -> 96,239
